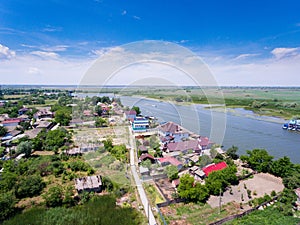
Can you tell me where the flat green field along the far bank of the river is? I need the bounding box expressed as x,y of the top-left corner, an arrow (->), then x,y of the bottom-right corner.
119,87 -> 300,119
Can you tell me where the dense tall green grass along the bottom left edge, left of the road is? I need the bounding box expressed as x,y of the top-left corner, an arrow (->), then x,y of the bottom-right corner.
3,195 -> 145,225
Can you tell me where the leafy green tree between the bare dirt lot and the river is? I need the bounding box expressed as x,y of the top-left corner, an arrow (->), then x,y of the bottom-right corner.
240,149 -> 273,172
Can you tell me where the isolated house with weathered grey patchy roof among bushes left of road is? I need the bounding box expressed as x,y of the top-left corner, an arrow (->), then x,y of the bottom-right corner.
75,175 -> 102,193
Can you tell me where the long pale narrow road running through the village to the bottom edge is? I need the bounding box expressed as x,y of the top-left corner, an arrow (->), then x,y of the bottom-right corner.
129,126 -> 157,225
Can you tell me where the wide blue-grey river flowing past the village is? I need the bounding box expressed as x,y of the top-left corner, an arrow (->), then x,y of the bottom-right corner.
121,96 -> 300,163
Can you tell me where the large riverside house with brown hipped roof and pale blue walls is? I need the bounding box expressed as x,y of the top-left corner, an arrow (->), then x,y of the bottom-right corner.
158,122 -> 190,142
